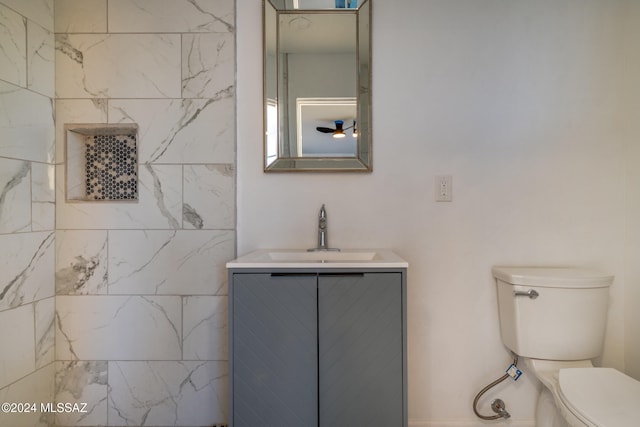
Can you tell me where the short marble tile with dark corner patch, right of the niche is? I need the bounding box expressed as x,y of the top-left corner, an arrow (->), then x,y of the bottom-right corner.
182,165 -> 236,229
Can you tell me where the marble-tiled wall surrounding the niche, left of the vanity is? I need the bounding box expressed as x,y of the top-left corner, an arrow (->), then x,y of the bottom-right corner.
52,0 -> 236,426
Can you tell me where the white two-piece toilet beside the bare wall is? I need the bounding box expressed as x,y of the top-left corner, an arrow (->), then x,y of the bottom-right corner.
492,267 -> 640,427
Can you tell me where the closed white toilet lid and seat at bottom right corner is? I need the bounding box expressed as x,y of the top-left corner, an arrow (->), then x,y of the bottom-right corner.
558,368 -> 640,427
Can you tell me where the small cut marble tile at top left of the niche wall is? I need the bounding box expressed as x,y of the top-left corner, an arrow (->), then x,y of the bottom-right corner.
54,0 -> 107,33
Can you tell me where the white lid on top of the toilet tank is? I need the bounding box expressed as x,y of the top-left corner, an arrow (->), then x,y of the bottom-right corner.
491,267 -> 613,288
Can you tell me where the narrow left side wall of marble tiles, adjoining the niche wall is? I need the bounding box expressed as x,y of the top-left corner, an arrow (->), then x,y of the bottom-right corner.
0,0 -> 55,427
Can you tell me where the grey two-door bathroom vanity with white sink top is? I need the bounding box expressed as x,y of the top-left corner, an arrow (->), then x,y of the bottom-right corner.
227,250 -> 407,427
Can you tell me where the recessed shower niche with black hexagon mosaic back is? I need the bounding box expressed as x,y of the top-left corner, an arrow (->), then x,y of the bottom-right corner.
65,125 -> 138,201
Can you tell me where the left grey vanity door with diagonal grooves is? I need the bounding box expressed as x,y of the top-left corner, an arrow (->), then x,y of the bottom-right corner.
232,274 -> 318,427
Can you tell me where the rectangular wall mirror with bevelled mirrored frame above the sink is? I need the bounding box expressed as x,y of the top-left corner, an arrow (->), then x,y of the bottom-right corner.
263,0 -> 372,172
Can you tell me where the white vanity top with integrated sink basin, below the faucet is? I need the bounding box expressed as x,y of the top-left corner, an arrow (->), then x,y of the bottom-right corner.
227,249 -> 408,268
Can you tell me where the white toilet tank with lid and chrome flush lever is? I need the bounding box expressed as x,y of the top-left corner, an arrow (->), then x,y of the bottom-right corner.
492,267 -> 613,360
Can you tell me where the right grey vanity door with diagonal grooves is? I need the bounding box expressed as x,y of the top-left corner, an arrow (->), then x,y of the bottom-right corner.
318,273 -> 406,427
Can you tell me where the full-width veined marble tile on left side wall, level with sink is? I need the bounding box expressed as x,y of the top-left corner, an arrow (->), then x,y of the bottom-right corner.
0,232 -> 55,312
